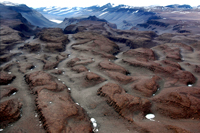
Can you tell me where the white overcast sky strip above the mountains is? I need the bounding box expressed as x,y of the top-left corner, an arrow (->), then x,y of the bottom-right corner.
0,0 -> 200,8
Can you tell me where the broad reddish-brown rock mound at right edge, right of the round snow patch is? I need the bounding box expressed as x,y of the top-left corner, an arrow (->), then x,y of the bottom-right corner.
152,87 -> 200,119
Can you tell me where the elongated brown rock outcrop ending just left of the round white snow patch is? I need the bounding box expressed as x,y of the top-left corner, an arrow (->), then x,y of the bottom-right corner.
97,83 -> 151,121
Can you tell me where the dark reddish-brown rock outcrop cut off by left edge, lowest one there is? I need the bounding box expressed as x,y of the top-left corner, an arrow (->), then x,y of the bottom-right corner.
0,99 -> 22,128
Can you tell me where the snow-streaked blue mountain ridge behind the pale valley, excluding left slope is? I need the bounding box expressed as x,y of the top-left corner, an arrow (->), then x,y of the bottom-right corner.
36,3 -> 199,30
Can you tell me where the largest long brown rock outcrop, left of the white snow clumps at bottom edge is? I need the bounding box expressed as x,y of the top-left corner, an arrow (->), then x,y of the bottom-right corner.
25,71 -> 92,133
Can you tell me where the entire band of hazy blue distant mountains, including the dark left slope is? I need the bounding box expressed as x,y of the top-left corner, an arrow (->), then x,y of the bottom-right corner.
0,2 -> 200,32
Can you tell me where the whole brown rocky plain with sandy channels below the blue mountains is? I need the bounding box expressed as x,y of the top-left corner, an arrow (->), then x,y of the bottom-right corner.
0,22 -> 200,133
